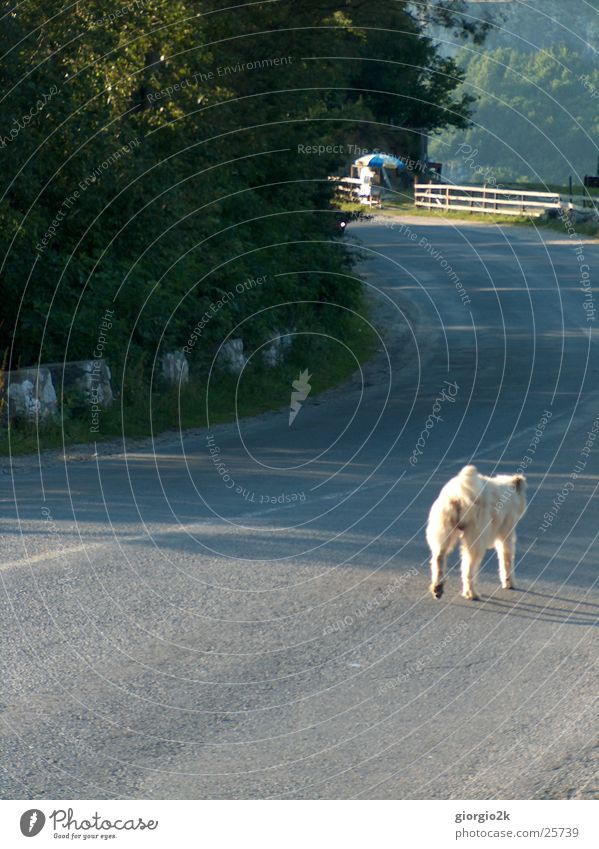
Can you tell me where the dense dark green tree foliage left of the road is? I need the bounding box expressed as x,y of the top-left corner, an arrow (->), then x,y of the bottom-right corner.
0,0 -> 478,367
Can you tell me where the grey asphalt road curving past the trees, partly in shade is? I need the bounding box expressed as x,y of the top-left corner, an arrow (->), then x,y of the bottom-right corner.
0,218 -> 599,799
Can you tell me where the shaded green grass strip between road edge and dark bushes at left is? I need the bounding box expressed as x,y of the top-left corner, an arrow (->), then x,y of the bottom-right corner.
0,306 -> 378,456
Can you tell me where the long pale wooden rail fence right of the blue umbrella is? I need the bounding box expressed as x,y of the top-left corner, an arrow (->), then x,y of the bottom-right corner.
414,183 -> 562,215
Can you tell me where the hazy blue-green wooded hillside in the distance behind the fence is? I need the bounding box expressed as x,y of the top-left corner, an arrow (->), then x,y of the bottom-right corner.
429,0 -> 599,185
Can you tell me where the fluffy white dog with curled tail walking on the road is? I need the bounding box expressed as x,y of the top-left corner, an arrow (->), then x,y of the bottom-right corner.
426,466 -> 526,600
